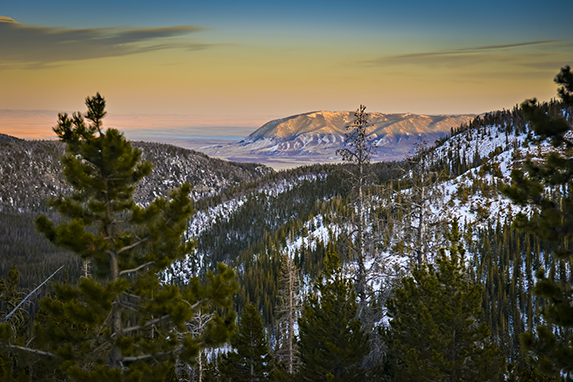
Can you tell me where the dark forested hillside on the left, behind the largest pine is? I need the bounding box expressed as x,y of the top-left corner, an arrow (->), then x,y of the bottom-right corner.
0,135 -> 273,302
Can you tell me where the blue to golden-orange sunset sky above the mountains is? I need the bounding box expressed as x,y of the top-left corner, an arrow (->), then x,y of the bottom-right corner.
0,0 -> 573,137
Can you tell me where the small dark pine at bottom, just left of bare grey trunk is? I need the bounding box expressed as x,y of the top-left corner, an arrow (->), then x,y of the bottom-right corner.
219,304 -> 274,382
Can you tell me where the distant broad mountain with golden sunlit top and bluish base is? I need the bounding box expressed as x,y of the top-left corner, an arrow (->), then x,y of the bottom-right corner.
203,111 -> 475,162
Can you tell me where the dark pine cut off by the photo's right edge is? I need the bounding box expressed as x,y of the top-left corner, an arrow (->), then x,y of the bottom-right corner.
502,66 -> 573,380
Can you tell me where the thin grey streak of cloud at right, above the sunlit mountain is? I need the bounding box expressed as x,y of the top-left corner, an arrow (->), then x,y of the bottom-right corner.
358,40 -> 563,67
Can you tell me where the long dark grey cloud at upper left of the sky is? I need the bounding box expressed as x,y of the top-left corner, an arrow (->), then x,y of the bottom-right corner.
0,16 -> 212,69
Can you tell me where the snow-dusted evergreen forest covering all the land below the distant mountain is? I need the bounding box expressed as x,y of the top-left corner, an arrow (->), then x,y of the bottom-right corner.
0,66 -> 573,382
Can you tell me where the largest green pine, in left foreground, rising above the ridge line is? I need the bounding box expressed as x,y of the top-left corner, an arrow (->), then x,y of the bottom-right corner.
0,94 -> 236,382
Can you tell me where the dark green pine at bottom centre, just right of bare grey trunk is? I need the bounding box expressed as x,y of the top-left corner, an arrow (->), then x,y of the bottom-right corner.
299,253 -> 369,382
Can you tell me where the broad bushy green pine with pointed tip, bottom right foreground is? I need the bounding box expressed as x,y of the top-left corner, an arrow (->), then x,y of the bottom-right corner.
385,222 -> 504,382
